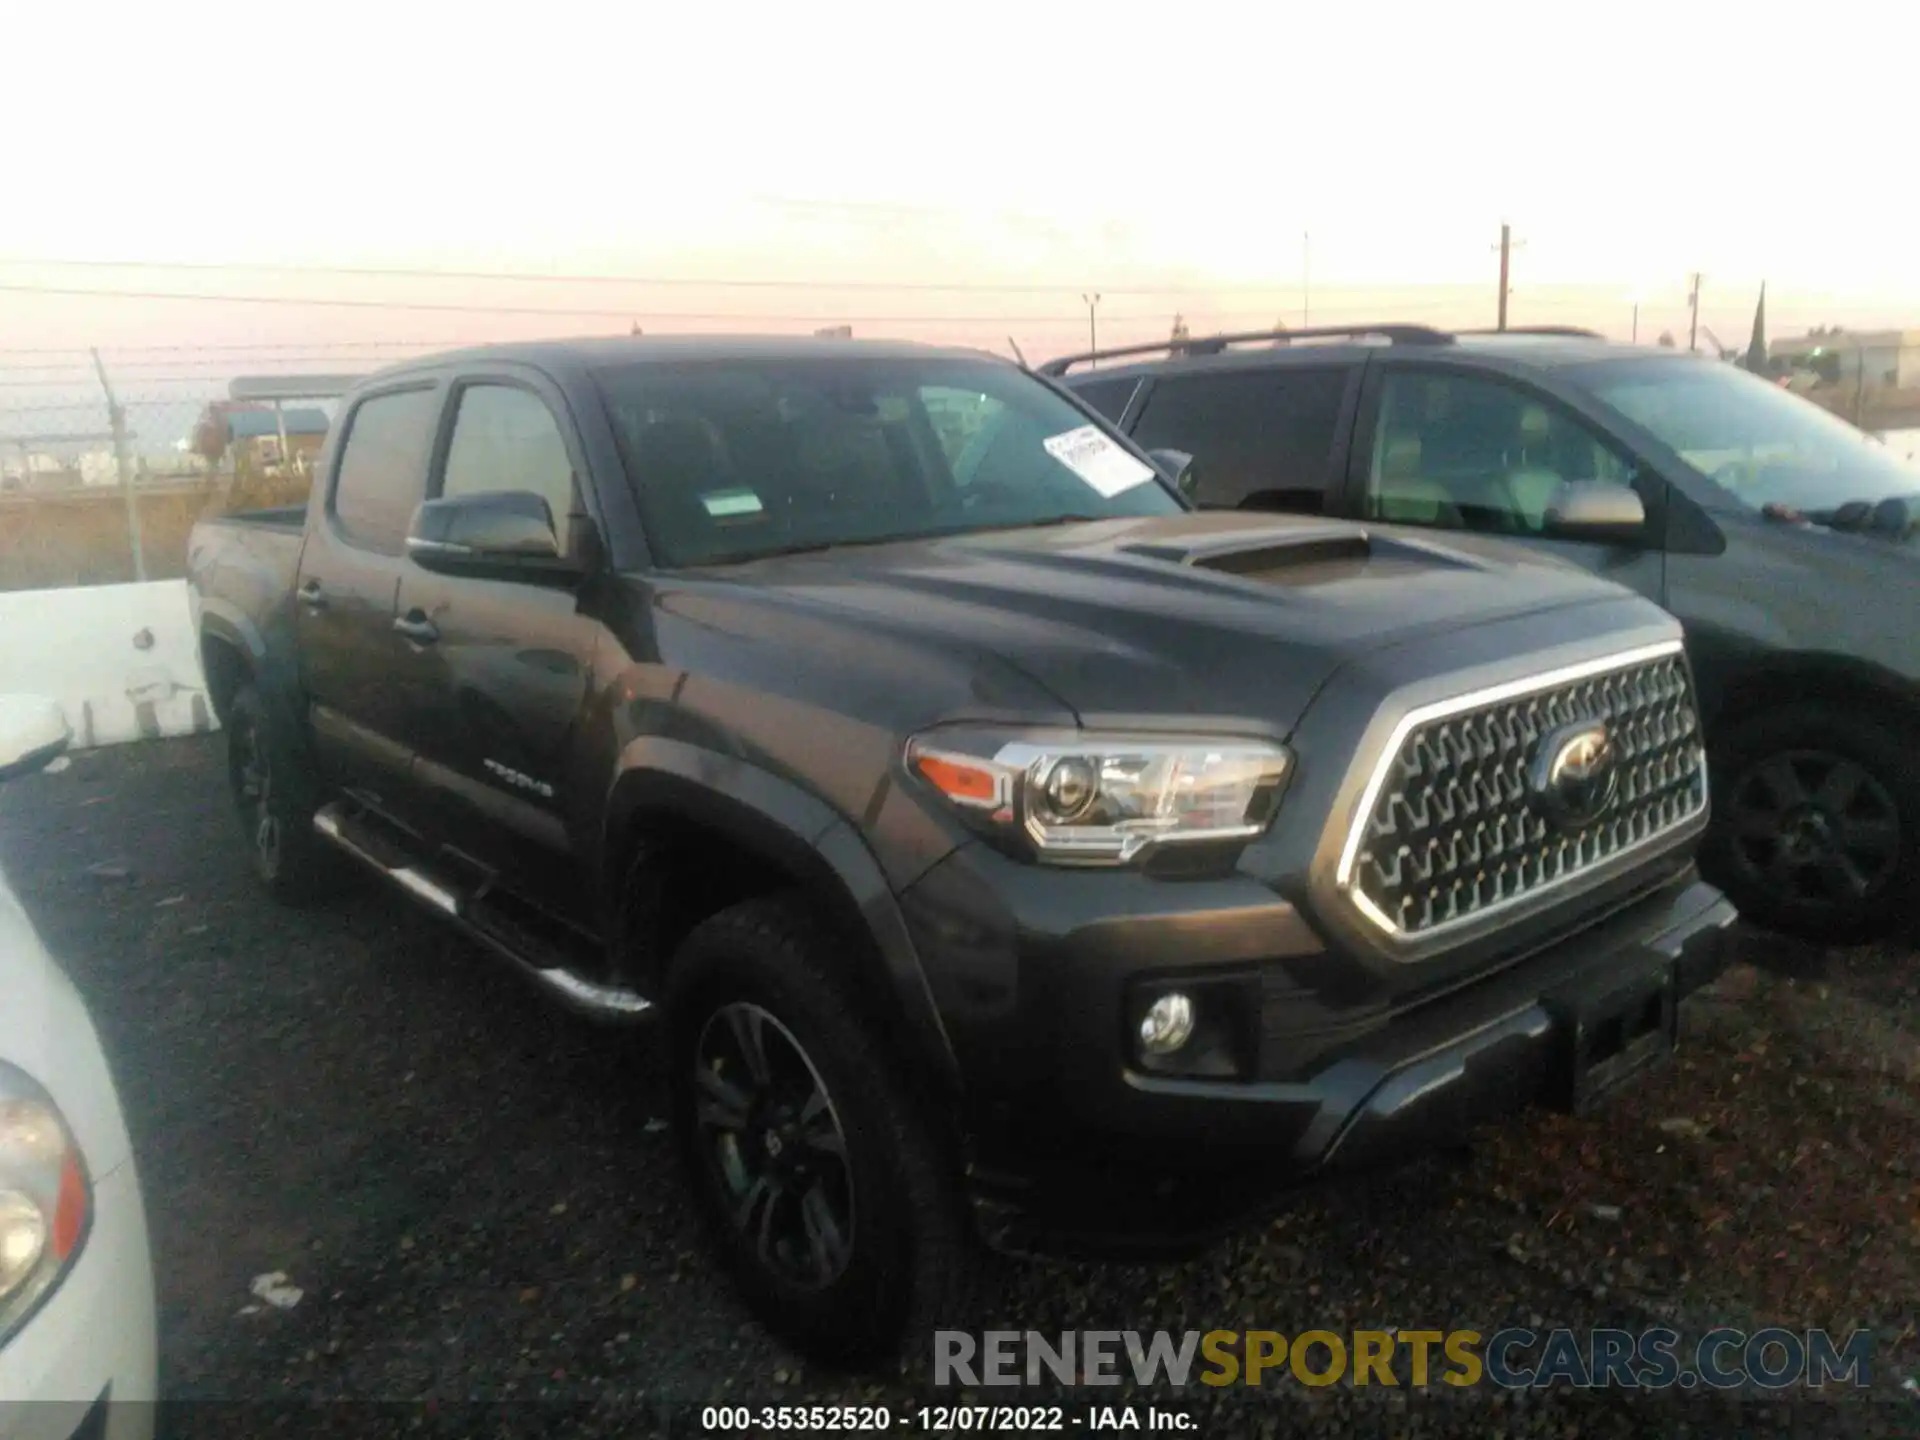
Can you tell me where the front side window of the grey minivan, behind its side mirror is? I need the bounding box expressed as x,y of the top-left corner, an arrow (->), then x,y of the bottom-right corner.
1367,371 -> 1634,536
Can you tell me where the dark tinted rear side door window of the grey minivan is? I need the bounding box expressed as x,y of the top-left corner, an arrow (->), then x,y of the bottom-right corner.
1133,367 -> 1350,513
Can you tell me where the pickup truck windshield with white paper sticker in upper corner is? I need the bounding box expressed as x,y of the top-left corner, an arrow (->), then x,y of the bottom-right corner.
599,355 -> 1185,566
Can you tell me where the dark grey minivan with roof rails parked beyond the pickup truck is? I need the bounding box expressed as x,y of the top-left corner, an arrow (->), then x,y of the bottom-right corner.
1041,324 -> 1920,943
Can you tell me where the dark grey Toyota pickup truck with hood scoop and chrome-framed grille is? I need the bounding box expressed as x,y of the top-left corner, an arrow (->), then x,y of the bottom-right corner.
188,340 -> 1732,1357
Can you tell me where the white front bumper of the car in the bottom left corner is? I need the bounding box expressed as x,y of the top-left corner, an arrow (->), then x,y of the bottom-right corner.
0,1162 -> 156,1440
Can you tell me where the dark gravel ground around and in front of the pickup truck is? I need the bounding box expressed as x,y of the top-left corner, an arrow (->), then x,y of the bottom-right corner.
0,737 -> 1920,1436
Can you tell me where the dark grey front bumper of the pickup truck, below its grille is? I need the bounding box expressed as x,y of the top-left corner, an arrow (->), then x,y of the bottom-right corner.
904,849 -> 1734,1244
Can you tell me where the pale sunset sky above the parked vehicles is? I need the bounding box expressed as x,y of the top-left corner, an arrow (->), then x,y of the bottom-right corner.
0,0 -> 1920,391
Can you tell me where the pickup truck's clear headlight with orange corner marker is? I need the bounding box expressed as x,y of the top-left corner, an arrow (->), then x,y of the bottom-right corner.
906,728 -> 1288,864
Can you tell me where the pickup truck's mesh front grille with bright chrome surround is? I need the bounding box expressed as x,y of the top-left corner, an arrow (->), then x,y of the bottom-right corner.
1340,641 -> 1707,941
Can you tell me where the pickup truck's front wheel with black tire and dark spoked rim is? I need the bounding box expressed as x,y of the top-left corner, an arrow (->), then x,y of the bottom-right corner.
666,897 -> 979,1367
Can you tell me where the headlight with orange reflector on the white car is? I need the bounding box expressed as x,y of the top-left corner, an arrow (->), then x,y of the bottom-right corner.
0,1064 -> 92,1344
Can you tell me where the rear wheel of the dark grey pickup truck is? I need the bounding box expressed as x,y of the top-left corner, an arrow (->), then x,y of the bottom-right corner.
227,685 -> 348,904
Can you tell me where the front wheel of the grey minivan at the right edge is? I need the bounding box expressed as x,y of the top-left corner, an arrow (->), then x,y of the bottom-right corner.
1701,703 -> 1920,945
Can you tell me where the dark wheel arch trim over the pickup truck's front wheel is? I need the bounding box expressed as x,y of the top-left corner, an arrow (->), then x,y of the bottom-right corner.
601,735 -> 960,1091
